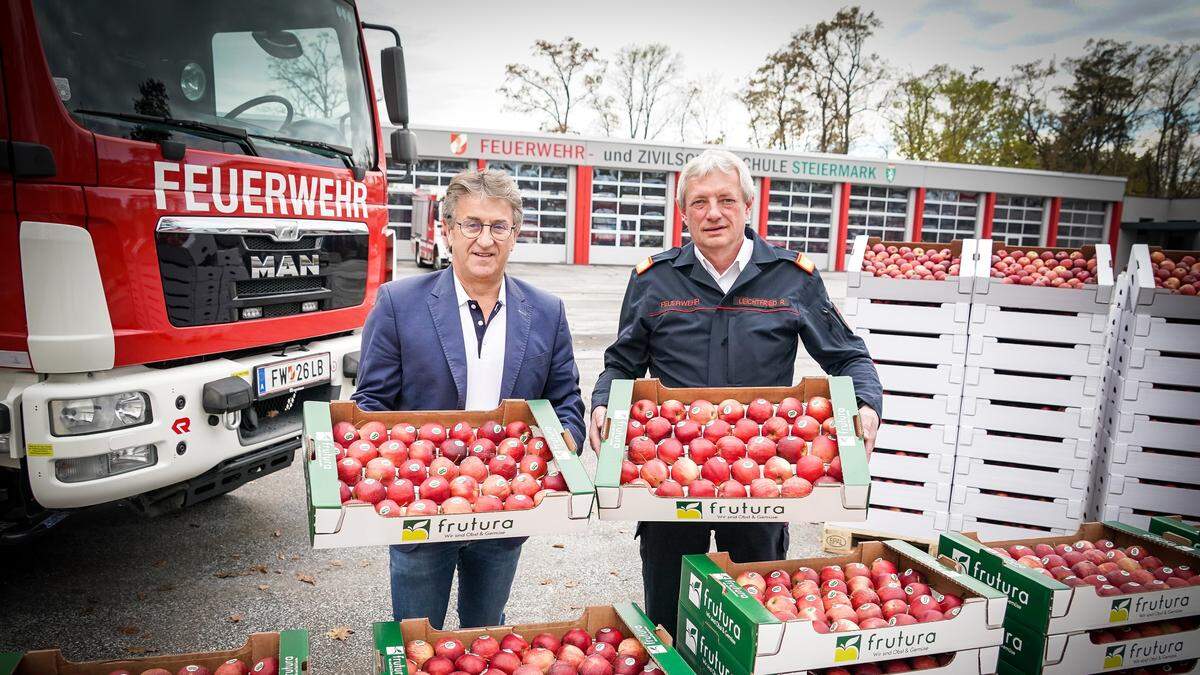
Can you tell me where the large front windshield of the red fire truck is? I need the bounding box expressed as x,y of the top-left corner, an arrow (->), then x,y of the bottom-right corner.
34,0 -> 376,172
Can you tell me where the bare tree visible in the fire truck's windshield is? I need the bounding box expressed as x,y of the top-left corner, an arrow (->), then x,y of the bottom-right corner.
269,32 -> 346,119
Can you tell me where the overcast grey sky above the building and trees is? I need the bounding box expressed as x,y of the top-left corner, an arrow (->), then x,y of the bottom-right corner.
359,0 -> 1200,156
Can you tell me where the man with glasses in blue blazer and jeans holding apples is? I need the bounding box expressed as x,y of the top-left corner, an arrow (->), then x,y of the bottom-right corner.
353,171 -> 586,628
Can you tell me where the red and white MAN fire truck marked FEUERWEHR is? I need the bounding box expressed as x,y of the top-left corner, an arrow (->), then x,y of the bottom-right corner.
0,0 -> 415,543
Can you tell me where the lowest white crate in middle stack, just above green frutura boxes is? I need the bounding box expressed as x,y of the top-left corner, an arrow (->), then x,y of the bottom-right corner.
950,483 -> 1087,530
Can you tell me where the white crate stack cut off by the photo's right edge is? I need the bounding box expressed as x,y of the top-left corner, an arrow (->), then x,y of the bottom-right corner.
1093,245 -> 1200,527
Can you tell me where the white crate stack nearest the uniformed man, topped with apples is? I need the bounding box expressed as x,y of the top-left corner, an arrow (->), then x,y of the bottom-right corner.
844,237 -> 976,539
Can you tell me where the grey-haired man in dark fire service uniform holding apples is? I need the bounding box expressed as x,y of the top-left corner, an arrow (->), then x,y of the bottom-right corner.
589,150 -> 883,631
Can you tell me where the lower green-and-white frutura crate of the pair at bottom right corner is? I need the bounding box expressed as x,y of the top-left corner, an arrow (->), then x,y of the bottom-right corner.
1000,623 -> 1200,675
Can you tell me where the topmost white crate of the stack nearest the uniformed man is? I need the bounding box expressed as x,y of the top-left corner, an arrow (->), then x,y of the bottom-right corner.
846,234 -> 977,303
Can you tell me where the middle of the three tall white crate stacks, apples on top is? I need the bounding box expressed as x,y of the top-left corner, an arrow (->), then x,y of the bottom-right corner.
950,240 -> 1114,539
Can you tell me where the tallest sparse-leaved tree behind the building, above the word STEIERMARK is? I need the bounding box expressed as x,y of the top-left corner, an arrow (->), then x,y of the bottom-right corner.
812,7 -> 887,153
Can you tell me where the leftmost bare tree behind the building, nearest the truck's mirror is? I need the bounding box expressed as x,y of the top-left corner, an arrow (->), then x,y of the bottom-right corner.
498,36 -> 602,133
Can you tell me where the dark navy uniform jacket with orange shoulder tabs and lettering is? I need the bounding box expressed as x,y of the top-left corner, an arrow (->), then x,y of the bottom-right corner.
592,228 -> 883,417
